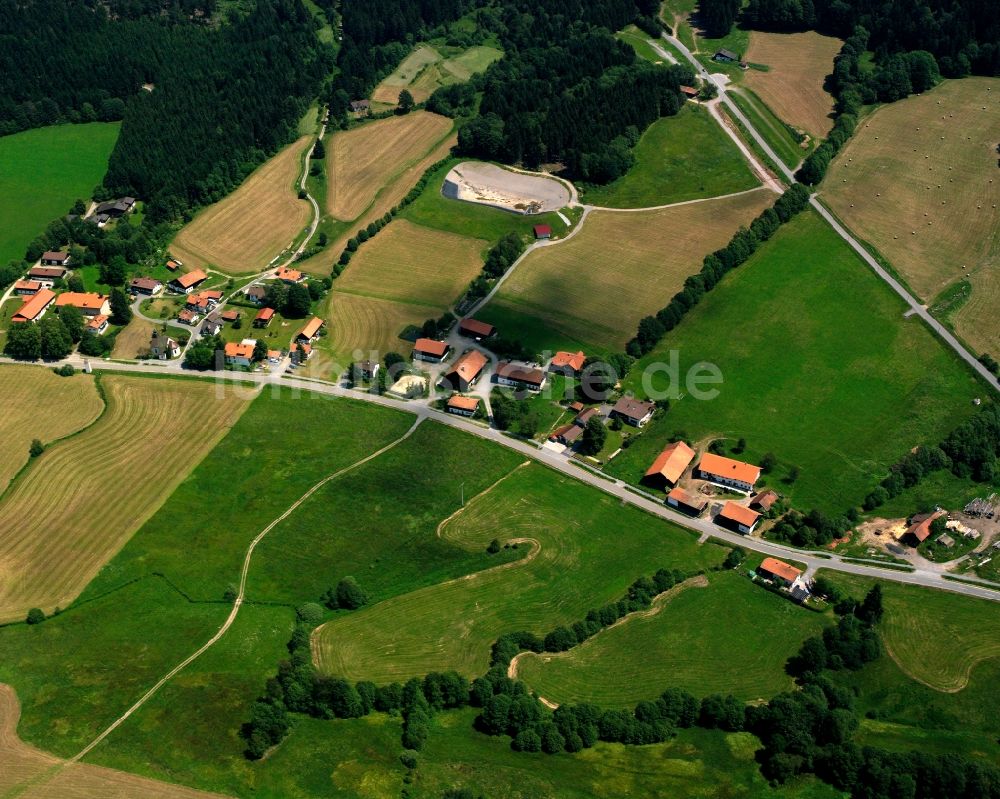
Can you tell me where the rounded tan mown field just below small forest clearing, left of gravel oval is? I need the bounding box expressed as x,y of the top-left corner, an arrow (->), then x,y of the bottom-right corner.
326,111 -> 453,222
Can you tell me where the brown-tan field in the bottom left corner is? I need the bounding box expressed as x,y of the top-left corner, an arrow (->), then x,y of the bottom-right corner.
0,685 -> 230,799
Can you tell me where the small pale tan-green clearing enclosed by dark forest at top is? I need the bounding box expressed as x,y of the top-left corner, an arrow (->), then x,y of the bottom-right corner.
372,44 -> 502,105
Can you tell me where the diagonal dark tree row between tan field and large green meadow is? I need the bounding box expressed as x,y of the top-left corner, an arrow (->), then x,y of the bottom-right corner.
625,183 -> 809,358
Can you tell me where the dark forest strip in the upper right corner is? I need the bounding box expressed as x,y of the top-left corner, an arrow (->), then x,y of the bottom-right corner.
740,0 -> 1000,77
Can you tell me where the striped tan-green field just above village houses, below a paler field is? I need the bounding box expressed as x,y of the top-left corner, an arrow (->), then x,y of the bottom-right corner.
316,290 -> 441,368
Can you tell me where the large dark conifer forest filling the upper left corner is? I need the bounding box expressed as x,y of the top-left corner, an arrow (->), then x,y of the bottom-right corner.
0,0 -> 333,219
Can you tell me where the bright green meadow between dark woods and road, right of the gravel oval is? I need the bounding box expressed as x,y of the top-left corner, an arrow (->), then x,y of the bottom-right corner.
581,103 -> 760,208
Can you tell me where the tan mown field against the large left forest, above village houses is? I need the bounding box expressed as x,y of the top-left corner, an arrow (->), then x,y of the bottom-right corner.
170,136 -> 312,275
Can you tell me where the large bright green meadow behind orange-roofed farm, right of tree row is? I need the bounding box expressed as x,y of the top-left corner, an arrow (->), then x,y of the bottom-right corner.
609,211 -> 982,514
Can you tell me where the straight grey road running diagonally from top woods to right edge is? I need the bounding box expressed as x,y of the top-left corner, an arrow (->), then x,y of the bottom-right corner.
653,34 -> 1000,392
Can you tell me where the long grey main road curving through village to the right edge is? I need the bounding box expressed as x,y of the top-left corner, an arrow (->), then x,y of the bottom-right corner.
19,357 -> 1000,602
